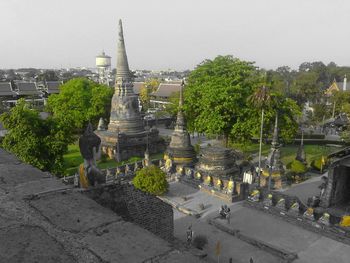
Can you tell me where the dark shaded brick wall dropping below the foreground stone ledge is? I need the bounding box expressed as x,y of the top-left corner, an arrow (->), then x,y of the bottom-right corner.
85,184 -> 174,241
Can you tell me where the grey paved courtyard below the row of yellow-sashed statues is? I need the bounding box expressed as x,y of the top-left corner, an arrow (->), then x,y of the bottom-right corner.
167,183 -> 350,263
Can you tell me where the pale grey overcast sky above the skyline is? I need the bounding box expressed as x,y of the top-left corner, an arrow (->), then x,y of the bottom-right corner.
0,0 -> 350,70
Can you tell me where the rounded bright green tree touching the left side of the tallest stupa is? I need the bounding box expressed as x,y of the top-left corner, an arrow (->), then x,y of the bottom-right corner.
47,78 -> 114,130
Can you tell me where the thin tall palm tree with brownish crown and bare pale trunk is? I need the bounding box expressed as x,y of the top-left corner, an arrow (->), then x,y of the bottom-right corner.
249,85 -> 271,184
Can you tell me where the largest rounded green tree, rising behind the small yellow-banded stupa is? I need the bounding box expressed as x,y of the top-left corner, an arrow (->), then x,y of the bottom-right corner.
184,56 -> 260,145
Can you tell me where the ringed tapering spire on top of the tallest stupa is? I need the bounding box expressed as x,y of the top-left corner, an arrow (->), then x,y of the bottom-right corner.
116,19 -> 131,81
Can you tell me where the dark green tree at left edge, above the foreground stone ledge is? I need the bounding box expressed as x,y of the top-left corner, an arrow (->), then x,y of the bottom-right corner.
0,99 -> 71,174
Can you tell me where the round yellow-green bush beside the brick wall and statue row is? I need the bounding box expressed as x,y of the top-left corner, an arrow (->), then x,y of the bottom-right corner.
132,165 -> 169,195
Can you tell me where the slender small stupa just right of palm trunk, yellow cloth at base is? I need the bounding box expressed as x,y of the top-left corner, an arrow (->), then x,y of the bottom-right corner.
260,114 -> 285,189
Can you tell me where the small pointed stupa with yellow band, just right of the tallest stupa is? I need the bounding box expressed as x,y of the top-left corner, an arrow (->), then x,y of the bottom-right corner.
166,82 -> 196,170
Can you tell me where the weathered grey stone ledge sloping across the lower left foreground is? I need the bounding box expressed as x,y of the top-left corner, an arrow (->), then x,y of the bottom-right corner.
0,149 -> 204,263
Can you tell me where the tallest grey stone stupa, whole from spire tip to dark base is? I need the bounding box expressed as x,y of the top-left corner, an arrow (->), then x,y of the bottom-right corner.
96,20 -> 165,161
